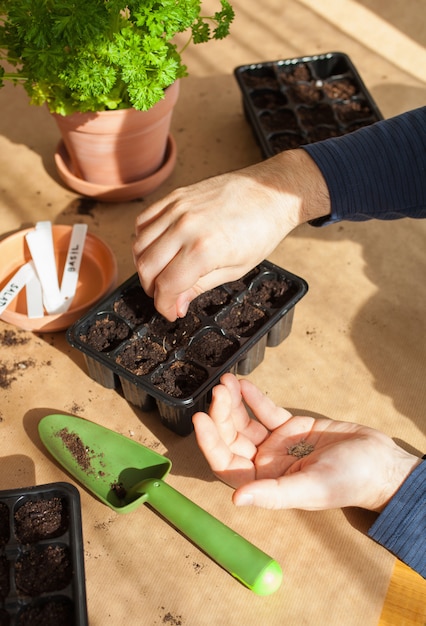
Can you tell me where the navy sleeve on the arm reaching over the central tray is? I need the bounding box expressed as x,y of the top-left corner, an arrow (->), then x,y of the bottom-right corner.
303,107 -> 426,226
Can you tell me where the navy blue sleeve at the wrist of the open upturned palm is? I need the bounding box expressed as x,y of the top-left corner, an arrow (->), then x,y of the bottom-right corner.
368,461 -> 426,578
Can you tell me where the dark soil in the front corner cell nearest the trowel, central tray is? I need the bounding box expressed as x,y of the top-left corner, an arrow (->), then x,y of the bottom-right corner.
152,361 -> 208,398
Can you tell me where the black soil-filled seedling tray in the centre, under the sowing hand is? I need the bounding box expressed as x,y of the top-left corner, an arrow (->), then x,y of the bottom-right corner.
67,261 -> 308,436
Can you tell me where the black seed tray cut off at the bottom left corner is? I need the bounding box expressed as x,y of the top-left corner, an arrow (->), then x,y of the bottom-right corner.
0,482 -> 88,626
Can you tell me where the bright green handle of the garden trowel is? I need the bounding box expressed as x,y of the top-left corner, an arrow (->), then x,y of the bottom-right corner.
137,479 -> 282,595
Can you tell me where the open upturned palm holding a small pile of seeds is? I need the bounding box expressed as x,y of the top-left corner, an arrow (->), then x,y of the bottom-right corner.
193,374 -> 420,511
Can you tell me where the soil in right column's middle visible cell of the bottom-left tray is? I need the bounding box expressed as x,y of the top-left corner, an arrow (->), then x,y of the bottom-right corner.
15,545 -> 73,596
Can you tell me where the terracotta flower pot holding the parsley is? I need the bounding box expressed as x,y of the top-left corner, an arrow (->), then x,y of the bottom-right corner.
52,81 -> 179,189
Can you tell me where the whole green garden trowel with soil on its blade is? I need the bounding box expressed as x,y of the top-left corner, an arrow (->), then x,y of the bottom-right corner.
38,414 -> 282,595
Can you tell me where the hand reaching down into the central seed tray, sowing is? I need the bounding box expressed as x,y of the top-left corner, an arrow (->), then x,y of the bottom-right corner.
133,150 -> 330,321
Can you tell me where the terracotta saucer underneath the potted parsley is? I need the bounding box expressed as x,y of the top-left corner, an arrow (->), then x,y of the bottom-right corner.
55,135 -> 177,202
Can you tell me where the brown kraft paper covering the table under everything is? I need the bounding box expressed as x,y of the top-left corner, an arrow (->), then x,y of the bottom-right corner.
0,0 -> 426,626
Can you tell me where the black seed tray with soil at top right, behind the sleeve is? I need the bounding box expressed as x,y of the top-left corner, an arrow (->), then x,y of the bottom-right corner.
234,52 -> 383,158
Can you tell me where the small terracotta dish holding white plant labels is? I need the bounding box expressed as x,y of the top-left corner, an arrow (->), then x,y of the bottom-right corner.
0,225 -> 118,332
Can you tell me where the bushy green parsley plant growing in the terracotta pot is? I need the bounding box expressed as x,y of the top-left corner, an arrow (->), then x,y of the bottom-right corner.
0,0 -> 234,115
